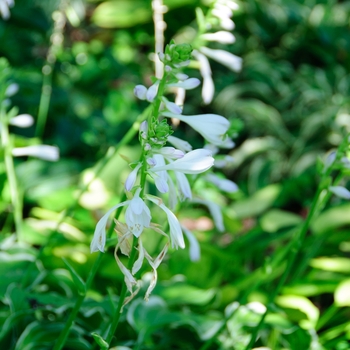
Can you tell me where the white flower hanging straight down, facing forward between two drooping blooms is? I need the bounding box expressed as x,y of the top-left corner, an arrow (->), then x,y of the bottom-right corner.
125,188 -> 151,237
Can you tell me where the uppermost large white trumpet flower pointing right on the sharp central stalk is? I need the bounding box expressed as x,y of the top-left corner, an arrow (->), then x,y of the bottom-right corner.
162,112 -> 230,147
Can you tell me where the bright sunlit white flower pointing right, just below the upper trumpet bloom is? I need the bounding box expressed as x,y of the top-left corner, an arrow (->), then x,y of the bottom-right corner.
152,148 -> 214,174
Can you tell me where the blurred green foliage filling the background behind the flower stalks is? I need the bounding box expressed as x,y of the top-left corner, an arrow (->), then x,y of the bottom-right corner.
0,0 -> 350,350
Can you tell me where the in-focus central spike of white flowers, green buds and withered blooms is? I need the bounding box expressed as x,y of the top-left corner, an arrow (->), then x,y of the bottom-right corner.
91,42 -> 237,303
